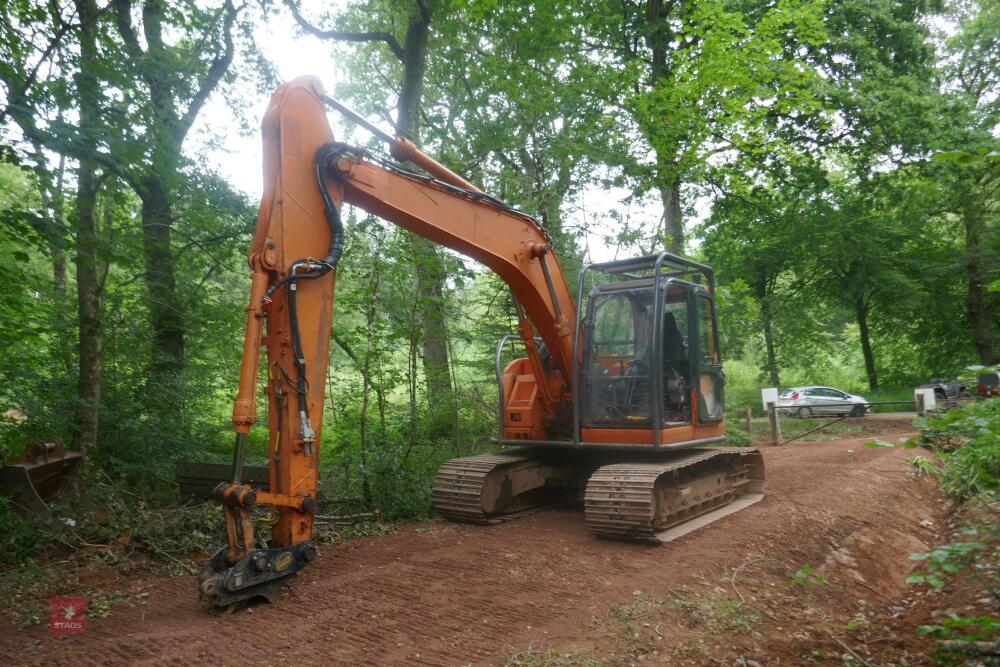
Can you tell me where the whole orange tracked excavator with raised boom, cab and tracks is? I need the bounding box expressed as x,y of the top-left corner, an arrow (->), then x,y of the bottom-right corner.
198,76 -> 764,607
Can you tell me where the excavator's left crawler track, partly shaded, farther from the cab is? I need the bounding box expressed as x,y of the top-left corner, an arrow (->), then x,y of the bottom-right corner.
431,450 -> 578,524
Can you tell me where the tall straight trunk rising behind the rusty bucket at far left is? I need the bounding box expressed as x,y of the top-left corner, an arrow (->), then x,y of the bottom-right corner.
73,0 -> 101,453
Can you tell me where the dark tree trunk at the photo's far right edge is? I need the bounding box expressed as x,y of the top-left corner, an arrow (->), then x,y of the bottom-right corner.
962,203 -> 1000,366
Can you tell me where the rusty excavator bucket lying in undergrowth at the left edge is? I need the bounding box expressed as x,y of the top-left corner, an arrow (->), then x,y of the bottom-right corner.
0,438 -> 83,516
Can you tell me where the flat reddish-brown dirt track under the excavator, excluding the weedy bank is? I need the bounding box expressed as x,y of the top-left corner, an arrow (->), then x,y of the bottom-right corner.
0,424 -> 940,665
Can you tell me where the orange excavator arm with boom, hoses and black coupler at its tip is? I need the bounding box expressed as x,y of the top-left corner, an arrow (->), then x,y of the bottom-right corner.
199,77 -> 576,606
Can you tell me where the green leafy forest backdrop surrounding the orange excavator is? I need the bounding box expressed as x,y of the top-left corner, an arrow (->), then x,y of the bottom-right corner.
0,0 -> 1000,519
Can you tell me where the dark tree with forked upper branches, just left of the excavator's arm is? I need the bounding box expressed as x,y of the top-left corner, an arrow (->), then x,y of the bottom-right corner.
113,0 -> 238,384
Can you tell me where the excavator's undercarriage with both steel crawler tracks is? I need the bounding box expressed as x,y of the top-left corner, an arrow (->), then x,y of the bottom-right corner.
432,447 -> 764,544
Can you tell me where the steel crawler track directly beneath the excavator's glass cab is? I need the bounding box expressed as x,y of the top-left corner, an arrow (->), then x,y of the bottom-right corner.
584,447 -> 764,544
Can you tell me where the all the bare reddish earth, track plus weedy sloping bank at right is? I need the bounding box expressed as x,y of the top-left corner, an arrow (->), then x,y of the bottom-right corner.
0,424 -> 944,665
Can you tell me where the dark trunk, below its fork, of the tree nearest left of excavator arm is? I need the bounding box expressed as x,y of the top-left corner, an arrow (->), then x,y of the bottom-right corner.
141,174 -> 184,382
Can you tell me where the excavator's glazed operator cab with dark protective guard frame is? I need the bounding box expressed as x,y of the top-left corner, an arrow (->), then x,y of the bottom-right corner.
578,253 -> 723,444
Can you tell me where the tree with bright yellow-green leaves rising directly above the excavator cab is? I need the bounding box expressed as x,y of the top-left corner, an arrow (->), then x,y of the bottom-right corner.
593,0 -> 826,252
